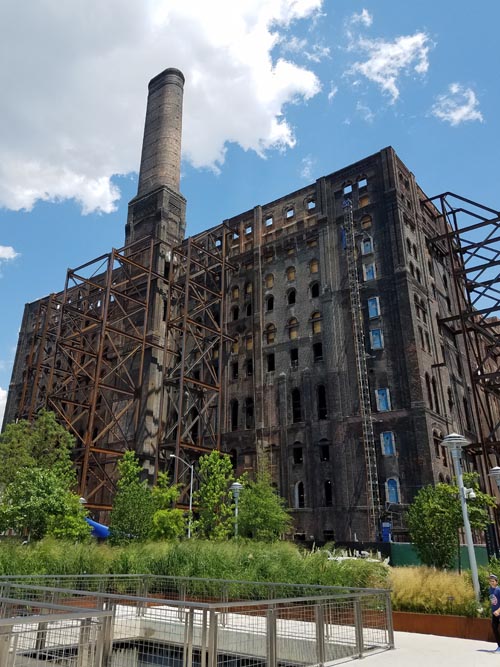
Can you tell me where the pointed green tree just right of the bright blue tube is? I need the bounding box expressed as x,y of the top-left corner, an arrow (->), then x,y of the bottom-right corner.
109,450 -> 155,544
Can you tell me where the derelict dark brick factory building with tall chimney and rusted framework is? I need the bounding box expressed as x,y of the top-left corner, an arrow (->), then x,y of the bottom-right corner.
5,70 -> 498,541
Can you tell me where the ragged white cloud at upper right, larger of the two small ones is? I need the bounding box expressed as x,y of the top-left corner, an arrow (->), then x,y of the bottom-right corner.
350,32 -> 432,103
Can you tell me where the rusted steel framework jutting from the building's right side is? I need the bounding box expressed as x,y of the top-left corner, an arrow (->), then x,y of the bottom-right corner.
423,192 -> 500,464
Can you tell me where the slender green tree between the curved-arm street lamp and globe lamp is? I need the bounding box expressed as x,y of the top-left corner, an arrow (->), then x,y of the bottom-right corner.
194,450 -> 234,540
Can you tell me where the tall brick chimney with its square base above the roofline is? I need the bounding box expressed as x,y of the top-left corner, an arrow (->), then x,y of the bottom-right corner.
125,67 -> 186,246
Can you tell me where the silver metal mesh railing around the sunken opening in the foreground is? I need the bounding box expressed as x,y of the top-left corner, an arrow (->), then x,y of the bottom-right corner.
0,575 -> 394,667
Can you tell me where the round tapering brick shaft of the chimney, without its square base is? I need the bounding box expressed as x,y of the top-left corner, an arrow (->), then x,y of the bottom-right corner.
137,67 -> 184,197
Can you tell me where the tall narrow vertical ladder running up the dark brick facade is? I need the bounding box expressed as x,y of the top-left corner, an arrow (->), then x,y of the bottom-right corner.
342,198 -> 380,541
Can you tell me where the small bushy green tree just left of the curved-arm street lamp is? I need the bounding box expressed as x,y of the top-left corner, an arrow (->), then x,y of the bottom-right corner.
151,473 -> 186,540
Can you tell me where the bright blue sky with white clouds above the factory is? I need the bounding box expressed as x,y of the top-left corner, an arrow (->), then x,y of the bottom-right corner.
0,0 -> 500,423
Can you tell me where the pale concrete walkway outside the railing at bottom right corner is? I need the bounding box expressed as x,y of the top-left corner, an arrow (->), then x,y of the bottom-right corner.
363,632 -> 500,667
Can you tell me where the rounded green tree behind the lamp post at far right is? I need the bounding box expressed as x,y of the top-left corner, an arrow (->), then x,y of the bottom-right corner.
407,473 -> 495,568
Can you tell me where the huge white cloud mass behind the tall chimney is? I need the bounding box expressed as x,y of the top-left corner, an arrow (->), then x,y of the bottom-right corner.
0,0 -> 320,212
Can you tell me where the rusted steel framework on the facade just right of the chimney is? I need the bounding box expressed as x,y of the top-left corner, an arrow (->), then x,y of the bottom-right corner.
157,225 -> 234,494
